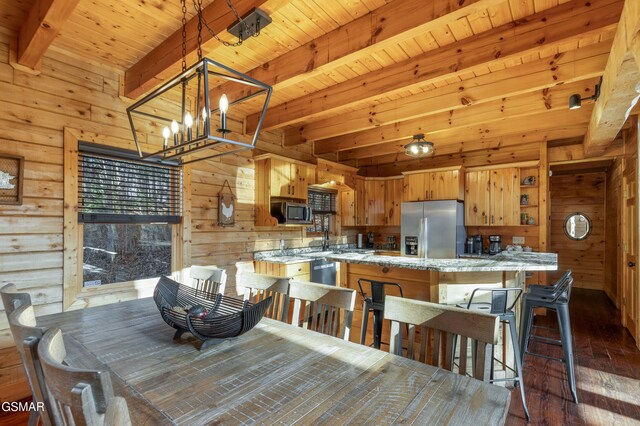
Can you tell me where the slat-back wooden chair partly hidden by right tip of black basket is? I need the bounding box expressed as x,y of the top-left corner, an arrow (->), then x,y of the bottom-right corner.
238,273 -> 289,322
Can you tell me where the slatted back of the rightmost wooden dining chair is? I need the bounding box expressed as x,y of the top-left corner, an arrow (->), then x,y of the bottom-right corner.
384,296 -> 500,381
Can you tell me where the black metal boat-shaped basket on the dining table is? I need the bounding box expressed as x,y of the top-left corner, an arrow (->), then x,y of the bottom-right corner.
153,277 -> 272,349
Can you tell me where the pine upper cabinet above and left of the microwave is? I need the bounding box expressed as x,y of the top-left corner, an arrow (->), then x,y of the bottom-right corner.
254,154 -> 316,226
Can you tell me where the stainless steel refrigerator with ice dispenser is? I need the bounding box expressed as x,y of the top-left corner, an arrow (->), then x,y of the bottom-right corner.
400,200 -> 467,259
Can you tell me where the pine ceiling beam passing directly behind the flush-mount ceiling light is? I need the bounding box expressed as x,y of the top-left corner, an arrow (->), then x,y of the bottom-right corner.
338,78 -> 598,161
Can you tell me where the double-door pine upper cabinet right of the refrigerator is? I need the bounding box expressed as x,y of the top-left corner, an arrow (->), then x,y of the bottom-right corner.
464,167 -> 520,226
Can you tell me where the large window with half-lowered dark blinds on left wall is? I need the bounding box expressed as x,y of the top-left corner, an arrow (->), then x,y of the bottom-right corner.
78,144 -> 182,287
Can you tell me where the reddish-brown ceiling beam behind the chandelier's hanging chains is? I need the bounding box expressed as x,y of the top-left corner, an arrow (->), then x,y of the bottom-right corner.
124,0 -> 290,99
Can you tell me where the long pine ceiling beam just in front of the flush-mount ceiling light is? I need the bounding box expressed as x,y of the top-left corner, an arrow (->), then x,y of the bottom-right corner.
312,42 -> 610,154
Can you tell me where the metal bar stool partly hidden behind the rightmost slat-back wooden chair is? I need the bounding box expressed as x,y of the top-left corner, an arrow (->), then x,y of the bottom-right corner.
454,288 -> 529,421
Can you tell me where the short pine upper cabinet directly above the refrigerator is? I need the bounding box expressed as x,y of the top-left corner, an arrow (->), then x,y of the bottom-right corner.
403,167 -> 464,201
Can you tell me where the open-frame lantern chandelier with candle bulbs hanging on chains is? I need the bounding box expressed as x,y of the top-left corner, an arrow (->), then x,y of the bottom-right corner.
127,0 -> 272,164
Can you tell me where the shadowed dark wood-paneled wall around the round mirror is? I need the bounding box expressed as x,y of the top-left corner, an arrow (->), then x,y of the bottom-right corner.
550,172 -> 606,290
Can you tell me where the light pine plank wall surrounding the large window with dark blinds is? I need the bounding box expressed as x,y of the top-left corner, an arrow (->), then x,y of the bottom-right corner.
0,33 -> 330,401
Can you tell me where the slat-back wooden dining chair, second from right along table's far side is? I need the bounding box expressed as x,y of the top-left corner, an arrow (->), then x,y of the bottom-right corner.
289,280 -> 356,340
